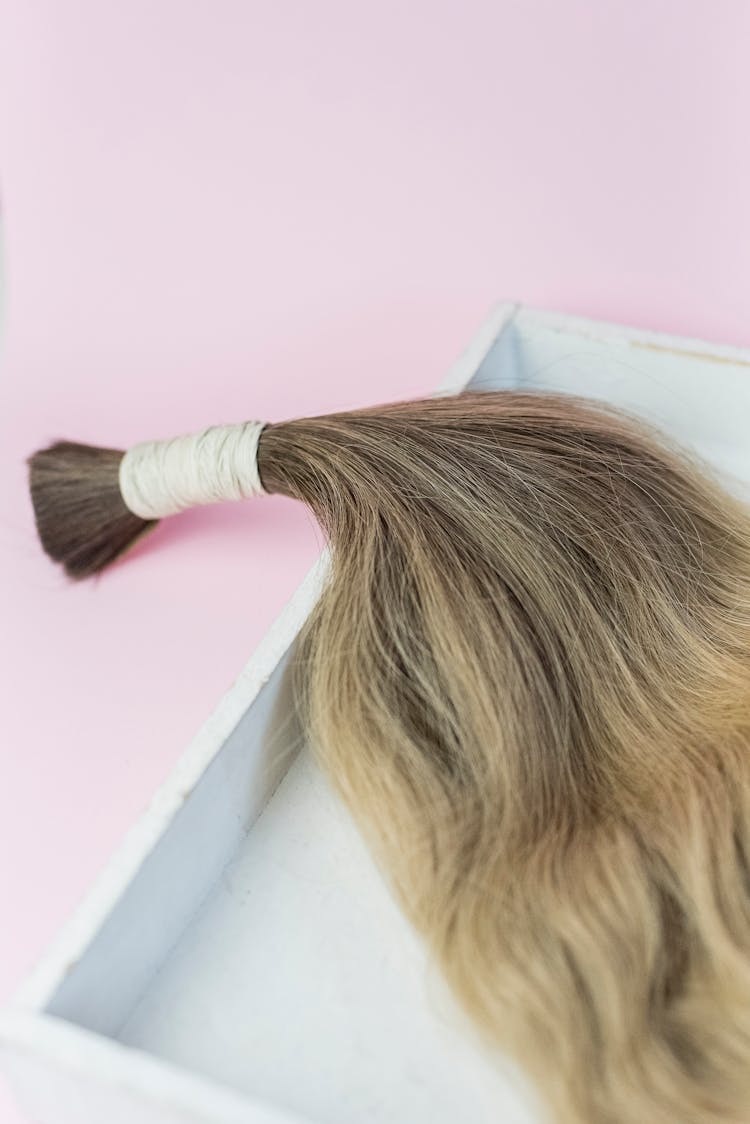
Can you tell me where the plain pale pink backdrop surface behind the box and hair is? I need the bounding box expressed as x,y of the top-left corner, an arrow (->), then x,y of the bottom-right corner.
0,0 -> 750,1122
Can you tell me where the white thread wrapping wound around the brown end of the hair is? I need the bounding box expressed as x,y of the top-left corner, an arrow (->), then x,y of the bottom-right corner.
119,422 -> 268,519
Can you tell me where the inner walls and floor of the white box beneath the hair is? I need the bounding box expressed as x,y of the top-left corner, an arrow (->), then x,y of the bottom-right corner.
36,309 -> 750,1124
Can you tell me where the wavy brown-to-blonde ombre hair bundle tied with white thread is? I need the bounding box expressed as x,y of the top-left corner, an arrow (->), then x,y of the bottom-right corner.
30,391 -> 750,1124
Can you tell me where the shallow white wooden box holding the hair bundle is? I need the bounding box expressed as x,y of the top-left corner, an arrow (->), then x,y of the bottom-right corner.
0,303 -> 750,1124
